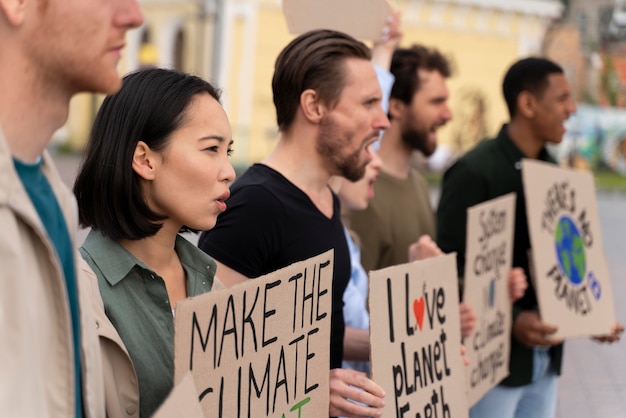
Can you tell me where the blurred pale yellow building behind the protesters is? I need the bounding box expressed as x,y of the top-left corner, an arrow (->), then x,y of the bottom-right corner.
61,0 -> 562,171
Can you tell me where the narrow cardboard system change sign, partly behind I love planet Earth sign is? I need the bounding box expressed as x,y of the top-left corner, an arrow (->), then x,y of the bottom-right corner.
463,193 -> 516,405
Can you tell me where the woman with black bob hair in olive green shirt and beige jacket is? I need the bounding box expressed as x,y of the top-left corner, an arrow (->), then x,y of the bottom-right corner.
74,69 -> 235,417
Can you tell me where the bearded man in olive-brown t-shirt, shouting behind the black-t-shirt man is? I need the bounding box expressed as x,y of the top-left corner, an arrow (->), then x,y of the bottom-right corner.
352,45 -> 452,271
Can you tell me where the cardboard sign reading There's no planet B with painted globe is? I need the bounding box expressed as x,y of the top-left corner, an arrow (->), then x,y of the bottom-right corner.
522,160 -> 616,338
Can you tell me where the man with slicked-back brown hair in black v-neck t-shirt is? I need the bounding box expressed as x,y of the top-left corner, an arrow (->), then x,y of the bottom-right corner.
199,30 -> 389,417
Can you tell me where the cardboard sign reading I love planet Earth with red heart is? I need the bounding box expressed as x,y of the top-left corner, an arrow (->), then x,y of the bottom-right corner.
369,253 -> 468,418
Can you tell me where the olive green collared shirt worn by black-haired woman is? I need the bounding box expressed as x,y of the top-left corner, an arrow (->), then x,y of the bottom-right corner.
80,230 -> 216,418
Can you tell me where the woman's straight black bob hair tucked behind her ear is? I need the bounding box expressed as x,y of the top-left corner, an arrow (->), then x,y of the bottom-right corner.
74,68 -> 220,241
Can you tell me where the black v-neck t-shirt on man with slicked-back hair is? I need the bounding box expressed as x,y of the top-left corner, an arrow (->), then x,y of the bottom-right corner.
198,164 -> 350,368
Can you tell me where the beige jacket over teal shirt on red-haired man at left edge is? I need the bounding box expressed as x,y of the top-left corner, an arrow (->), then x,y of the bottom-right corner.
0,130 -> 104,418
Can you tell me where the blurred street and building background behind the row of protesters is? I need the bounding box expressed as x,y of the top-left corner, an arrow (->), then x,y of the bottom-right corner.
51,0 -> 626,418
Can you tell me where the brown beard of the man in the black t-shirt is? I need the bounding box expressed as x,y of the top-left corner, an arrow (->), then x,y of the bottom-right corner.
316,116 -> 367,181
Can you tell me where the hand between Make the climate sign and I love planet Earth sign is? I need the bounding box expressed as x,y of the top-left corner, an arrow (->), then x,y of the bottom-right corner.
328,369 -> 385,418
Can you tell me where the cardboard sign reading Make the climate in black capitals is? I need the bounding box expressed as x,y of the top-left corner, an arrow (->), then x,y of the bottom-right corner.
174,250 -> 334,418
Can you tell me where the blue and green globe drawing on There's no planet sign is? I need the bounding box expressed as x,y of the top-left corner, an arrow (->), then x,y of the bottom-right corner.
554,216 -> 587,285
